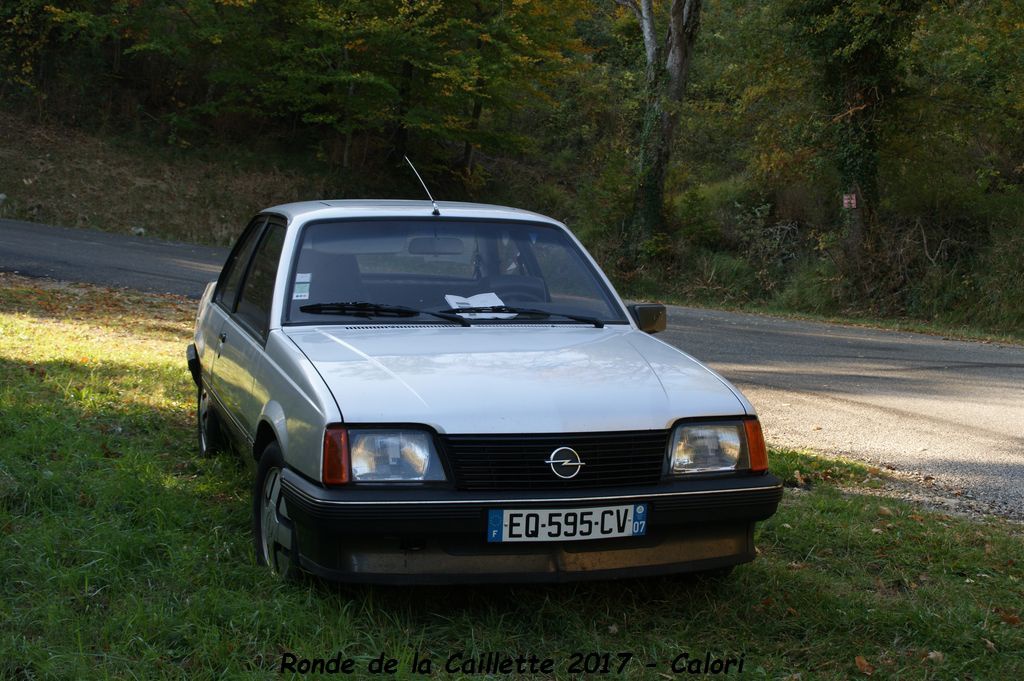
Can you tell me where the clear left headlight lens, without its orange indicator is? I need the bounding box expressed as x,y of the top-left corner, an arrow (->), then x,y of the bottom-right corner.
348,429 -> 444,482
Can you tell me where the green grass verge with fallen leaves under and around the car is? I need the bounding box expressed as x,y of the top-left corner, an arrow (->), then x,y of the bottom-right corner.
0,275 -> 1024,679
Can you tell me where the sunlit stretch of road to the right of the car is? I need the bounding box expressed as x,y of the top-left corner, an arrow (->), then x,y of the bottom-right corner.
662,306 -> 1024,518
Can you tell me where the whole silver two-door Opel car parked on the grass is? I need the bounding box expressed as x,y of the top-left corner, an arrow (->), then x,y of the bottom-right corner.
187,201 -> 781,583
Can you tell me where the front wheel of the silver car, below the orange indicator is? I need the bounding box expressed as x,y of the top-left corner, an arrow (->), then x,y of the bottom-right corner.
253,442 -> 299,579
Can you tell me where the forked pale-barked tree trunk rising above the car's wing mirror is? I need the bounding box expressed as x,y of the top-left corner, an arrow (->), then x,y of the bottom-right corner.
615,0 -> 701,246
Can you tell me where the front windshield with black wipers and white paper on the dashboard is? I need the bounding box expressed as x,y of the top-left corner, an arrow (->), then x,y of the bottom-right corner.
286,218 -> 627,324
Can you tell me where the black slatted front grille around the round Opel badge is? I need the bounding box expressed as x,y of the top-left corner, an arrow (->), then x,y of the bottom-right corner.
442,430 -> 669,490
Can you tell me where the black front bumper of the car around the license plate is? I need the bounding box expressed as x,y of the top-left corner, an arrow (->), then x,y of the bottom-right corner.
282,469 -> 782,584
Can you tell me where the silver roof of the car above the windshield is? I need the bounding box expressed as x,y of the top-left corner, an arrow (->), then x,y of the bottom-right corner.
261,199 -> 561,225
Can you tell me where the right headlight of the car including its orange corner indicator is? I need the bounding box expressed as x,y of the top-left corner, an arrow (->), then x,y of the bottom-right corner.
669,419 -> 767,476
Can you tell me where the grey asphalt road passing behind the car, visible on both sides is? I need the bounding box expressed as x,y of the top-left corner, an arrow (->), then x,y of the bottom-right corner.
0,220 -> 1024,517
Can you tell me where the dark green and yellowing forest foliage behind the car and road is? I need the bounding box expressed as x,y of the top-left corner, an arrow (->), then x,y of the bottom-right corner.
0,0 -> 1024,333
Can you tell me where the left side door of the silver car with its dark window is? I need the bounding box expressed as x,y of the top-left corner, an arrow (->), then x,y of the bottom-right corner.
213,221 -> 285,440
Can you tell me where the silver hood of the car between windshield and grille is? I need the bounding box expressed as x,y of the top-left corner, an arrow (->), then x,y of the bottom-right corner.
285,325 -> 751,433
